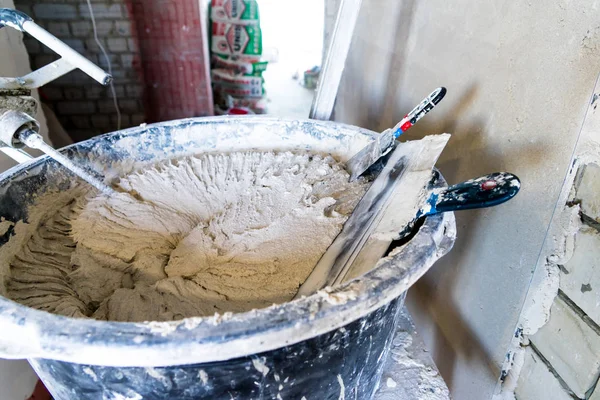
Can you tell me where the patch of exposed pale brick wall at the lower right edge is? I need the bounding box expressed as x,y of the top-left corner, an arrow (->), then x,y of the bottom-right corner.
515,162 -> 600,400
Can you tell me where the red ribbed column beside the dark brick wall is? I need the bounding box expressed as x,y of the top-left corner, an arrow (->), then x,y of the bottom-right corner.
127,0 -> 213,122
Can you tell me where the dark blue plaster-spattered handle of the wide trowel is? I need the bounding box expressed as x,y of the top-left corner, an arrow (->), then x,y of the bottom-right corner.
421,172 -> 521,215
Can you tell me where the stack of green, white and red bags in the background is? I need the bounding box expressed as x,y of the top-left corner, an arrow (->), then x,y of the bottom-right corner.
210,0 -> 267,115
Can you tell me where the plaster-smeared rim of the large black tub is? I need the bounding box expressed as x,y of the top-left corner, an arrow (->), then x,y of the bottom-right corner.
0,116 -> 456,367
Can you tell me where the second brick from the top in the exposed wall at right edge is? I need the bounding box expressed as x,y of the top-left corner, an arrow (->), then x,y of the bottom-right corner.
560,226 -> 600,324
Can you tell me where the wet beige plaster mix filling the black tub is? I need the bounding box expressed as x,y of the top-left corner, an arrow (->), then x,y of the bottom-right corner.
0,151 -> 367,321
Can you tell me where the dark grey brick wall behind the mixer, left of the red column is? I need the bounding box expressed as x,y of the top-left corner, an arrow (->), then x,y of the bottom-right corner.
15,0 -> 146,141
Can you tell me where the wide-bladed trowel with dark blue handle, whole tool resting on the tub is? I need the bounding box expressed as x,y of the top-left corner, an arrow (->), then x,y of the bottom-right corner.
295,134 -> 520,298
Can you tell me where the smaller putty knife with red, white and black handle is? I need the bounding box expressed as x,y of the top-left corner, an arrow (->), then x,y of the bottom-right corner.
346,87 -> 446,182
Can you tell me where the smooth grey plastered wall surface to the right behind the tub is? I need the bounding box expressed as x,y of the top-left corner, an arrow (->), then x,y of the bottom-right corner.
326,0 -> 600,400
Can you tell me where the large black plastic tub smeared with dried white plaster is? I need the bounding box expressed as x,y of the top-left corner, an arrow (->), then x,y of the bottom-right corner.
0,117 -> 455,400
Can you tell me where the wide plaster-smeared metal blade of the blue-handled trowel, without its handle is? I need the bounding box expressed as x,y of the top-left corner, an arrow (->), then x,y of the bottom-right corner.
295,133 -> 450,298
